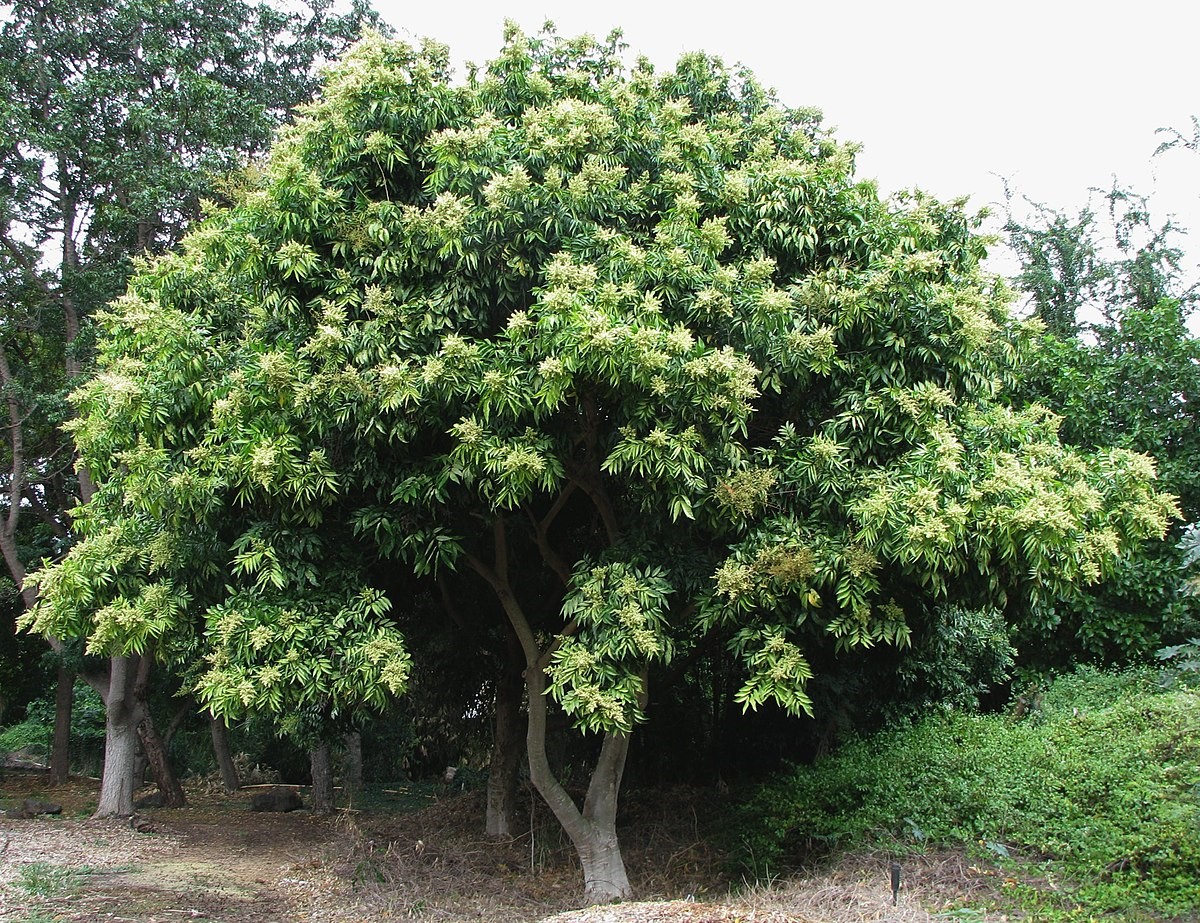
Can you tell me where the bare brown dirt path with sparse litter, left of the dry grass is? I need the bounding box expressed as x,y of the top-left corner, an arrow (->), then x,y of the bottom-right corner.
0,777 -> 353,923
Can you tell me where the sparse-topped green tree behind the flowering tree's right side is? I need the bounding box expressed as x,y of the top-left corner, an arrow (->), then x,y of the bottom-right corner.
1006,186 -> 1200,665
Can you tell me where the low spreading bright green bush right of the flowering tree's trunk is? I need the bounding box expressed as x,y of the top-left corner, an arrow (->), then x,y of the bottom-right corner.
740,670 -> 1200,913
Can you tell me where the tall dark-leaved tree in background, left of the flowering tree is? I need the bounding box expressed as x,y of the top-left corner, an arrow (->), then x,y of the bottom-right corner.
0,0 -> 378,814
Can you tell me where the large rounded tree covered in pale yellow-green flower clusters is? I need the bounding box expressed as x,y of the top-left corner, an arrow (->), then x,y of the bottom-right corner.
34,26 -> 1172,900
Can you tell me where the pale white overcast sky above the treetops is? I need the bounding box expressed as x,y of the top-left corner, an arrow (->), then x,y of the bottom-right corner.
376,0 -> 1200,276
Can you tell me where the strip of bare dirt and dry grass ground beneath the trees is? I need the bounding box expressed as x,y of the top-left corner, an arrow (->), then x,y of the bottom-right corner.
0,772 -> 1002,923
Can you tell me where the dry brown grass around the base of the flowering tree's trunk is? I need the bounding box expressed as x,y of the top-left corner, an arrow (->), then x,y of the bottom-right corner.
300,790 -> 1003,923
